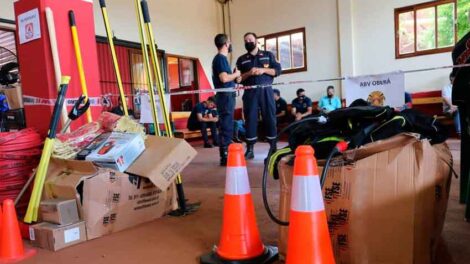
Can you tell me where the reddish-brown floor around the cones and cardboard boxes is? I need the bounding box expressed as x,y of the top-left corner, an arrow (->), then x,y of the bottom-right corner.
24,140 -> 470,264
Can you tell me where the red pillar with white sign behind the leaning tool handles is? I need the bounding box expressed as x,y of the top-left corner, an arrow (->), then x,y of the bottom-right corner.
14,0 -> 102,134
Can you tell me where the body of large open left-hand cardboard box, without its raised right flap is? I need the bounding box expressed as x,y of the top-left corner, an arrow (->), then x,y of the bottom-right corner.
45,160 -> 176,239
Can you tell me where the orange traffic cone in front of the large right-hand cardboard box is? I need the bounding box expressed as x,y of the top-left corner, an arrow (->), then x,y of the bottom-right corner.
286,146 -> 335,264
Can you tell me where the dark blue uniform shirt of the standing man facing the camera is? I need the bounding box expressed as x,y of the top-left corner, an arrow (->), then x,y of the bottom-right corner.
237,50 -> 281,85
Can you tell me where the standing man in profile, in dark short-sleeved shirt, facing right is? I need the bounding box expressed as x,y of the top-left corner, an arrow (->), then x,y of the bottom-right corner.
212,34 -> 241,166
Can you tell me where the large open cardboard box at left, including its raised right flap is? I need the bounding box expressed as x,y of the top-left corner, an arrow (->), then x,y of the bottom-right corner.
44,136 -> 197,239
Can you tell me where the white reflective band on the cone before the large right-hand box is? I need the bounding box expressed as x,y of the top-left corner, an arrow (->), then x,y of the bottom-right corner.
291,176 -> 325,212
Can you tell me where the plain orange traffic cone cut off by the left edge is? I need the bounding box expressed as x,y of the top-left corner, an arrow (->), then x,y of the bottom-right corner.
0,199 -> 36,263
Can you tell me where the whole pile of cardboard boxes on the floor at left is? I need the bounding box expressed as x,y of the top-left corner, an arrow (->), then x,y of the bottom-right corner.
25,133 -> 197,251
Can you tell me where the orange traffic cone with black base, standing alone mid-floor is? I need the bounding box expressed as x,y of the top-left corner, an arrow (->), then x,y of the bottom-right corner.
200,144 -> 278,264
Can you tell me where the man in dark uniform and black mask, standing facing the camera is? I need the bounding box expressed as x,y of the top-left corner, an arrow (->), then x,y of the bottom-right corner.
237,32 -> 281,159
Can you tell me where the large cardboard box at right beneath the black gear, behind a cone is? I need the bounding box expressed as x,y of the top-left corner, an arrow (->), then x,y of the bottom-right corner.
278,134 -> 452,264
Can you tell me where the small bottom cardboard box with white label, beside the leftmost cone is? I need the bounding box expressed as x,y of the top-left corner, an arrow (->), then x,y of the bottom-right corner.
29,221 -> 87,251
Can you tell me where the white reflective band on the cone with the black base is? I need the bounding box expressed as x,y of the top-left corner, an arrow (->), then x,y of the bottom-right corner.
225,167 -> 251,195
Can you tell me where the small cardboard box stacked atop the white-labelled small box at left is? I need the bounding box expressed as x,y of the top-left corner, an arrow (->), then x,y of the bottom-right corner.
39,199 -> 80,225
